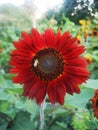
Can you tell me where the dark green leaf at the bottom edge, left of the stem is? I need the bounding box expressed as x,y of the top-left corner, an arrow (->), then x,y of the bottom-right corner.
8,111 -> 35,130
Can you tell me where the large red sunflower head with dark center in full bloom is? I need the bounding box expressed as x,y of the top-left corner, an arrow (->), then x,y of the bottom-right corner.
10,29 -> 89,104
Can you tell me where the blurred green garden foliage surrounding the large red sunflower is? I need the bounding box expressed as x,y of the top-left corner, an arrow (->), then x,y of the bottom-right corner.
0,0 -> 98,130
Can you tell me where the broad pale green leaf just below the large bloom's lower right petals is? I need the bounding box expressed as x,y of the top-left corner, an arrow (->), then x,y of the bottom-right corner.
65,89 -> 94,109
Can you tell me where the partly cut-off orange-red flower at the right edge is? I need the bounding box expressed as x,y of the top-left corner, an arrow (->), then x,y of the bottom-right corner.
91,90 -> 98,118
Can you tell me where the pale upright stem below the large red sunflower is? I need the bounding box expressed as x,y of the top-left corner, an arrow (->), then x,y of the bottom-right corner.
39,101 -> 44,130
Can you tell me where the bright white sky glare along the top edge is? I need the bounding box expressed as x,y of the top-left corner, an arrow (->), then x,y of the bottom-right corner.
0,0 -> 63,18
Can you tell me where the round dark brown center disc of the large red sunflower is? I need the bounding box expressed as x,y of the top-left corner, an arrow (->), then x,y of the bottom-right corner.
32,48 -> 64,81
